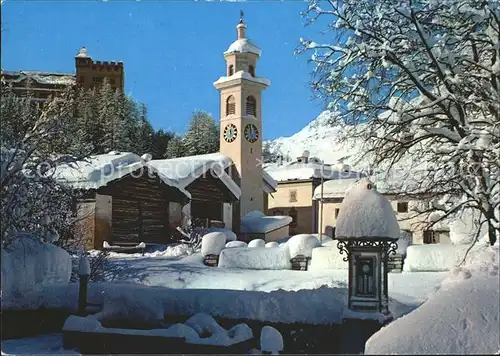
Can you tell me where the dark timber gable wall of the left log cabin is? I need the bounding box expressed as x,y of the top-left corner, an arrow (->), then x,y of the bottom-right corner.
99,175 -> 178,243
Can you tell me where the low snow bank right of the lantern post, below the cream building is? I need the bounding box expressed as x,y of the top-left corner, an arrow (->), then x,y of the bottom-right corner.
403,244 -> 477,272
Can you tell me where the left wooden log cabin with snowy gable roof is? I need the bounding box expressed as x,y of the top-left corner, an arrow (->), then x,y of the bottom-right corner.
56,152 -> 189,249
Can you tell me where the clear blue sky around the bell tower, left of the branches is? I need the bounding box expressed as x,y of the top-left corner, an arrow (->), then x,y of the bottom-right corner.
2,0 -> 332,139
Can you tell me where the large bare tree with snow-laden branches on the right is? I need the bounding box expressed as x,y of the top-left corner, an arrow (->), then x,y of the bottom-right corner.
298,0 -> 500,244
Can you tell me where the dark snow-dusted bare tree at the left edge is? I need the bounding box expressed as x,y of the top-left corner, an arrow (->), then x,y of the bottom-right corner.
0,91 -> 79,246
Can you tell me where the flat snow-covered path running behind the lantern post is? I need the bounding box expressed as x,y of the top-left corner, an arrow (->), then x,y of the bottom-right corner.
101,253 -> 447,308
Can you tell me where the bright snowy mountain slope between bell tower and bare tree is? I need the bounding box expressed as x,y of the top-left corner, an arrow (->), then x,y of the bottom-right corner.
264,111 -> 357,164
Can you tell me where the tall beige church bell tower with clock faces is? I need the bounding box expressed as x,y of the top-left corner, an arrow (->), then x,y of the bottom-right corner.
214,12 -> 270,217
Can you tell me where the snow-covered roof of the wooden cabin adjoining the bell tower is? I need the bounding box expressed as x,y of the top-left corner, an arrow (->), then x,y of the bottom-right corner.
148,153 -> 241,198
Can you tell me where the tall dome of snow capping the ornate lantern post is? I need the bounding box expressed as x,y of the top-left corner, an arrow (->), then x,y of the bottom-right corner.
335,178 -> 400,239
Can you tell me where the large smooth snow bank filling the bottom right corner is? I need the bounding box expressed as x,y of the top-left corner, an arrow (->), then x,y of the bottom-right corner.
365,247 -> 500,355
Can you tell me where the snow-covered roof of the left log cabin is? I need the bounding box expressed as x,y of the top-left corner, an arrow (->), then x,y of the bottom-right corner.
54,151 -> 191,198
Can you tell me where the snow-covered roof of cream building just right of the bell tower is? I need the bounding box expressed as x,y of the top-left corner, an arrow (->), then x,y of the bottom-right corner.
266,162 -> 361,182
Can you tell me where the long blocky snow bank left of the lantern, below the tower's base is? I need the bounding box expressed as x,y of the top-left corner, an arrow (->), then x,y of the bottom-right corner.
219,247 -> 292,269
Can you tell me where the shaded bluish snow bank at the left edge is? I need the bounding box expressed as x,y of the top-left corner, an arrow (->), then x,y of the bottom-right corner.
2,235 -> 72,303
